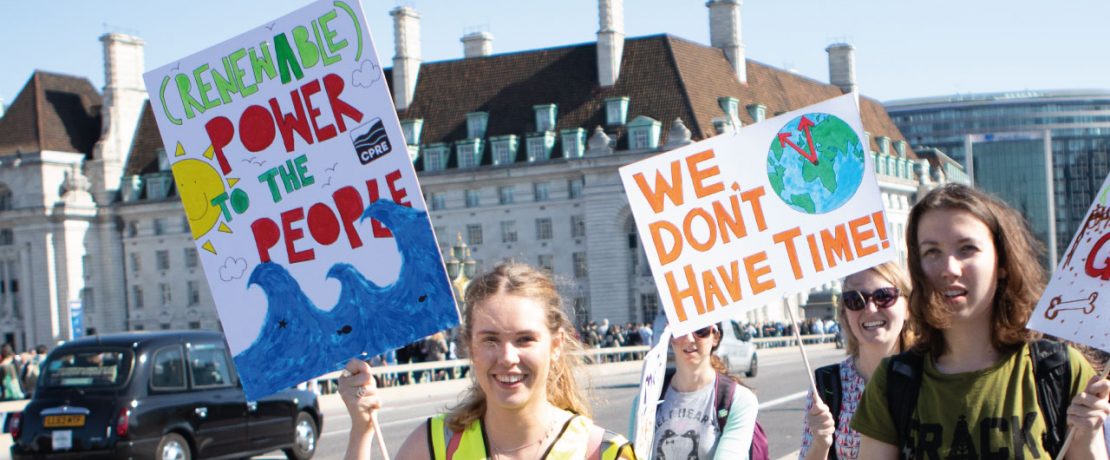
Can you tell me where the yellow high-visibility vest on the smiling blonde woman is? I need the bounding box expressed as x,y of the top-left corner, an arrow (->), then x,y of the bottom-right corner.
427,413 -> 636,460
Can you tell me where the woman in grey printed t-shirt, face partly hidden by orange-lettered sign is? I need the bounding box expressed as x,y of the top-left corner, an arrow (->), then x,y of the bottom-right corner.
632,324 -> 759,460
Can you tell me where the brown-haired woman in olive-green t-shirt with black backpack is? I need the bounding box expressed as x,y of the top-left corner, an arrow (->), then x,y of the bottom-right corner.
851,184 -> 1110,460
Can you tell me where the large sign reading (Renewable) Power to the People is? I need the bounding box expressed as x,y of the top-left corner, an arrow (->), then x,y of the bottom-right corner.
144,0 -> 458,399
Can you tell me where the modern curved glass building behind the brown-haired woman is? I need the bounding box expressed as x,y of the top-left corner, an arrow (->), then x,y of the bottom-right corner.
885,90 -> 1110,267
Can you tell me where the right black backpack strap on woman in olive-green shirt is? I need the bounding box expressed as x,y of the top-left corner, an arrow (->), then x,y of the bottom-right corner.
1029,339 -> 1071,458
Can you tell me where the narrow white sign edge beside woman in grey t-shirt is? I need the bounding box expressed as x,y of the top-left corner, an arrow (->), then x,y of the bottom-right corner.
633,328 -> 670,460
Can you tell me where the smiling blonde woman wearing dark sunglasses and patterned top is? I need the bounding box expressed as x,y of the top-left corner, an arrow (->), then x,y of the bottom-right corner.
798,262 -> 914,460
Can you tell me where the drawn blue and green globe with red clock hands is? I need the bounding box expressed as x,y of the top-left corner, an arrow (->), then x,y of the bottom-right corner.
767,113 -> 866,214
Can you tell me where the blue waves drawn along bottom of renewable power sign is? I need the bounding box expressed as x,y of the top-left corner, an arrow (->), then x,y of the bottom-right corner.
234,199 -> 458,400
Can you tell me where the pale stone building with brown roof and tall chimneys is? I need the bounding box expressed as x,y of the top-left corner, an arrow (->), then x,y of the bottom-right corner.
0,0 -> 963,348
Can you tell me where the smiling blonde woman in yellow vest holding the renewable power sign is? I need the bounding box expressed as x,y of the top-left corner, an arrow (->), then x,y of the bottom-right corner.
340,263 -> 634,460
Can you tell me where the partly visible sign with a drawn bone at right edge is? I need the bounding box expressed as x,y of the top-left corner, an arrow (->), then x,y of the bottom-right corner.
1028,177 -> 1110,351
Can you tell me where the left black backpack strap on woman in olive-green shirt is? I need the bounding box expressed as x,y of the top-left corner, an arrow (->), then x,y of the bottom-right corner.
886,351 -> 925,459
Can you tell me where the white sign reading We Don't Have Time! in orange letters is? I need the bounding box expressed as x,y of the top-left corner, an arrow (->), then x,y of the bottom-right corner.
620,94 -> 896,334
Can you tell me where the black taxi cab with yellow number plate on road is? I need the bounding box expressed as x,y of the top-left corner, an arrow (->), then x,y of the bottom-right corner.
9,331 -> 323,460
